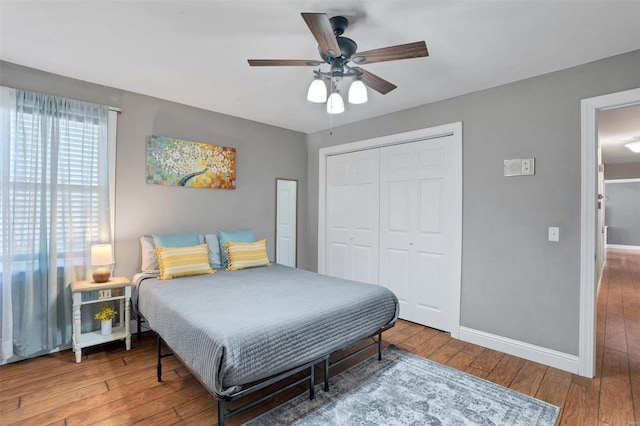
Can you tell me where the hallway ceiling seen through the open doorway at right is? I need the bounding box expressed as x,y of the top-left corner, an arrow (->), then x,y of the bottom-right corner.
598,104 -> 640,164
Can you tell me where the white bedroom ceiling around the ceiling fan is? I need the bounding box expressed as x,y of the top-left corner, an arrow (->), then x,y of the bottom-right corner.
0,0 -> 640,133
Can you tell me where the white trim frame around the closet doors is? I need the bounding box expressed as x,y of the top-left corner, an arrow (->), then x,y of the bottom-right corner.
318,121 -> 462,339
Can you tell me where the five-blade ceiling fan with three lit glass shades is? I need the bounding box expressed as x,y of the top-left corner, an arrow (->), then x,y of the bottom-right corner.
248,13 -> 429,114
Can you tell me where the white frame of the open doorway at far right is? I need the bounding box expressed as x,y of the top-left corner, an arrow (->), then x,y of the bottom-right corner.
578,89 -> 640,377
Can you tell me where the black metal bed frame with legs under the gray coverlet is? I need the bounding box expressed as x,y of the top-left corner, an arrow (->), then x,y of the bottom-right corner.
156,317 -> 395,426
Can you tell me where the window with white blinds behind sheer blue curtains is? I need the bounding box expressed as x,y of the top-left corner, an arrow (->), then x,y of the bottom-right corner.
6,106 -> 113,260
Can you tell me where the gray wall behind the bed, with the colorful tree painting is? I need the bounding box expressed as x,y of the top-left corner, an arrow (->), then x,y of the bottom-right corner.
0,62 -> 309,277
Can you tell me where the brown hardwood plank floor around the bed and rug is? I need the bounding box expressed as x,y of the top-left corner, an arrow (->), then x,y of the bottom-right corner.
0,250 -> 640,426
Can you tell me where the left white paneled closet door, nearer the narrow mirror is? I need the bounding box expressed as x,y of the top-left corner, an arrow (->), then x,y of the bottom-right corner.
325,149 -> 380,284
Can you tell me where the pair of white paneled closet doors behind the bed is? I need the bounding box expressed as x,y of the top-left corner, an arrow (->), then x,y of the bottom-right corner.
325,136 -> 462,331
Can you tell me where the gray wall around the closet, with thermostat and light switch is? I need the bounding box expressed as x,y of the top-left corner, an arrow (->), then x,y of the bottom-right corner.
307,51 -> 640,355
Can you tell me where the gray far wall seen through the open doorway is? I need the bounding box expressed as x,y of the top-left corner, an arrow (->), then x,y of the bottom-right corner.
604,180 -> 640,247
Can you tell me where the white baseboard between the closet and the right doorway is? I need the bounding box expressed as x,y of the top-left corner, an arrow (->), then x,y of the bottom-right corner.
460,327 -> 580,374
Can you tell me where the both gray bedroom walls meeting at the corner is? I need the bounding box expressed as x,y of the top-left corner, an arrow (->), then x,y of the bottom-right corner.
5,51 -> 640,355
